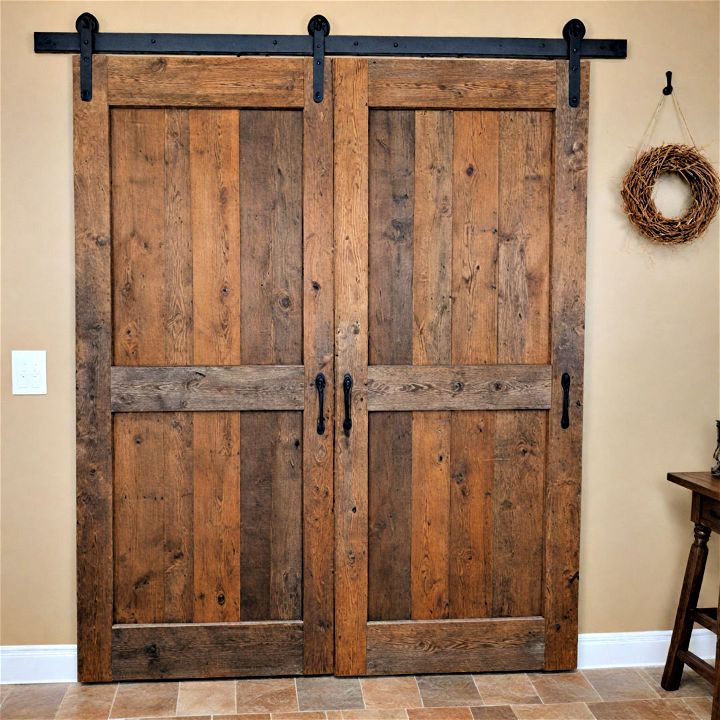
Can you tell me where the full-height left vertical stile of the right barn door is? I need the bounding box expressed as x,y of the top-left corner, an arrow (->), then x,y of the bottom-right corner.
333,58 -> 368,675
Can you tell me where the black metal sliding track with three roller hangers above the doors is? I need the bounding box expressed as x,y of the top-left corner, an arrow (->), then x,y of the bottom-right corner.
35,13 -> 627,106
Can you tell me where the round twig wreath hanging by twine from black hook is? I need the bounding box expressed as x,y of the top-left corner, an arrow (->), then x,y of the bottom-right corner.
620,70 -> 720,245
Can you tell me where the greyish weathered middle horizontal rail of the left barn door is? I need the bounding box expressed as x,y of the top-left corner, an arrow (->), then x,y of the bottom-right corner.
110,365 -> 305,412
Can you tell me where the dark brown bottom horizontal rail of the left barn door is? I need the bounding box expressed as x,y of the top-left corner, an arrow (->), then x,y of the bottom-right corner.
112,621 -> 303,680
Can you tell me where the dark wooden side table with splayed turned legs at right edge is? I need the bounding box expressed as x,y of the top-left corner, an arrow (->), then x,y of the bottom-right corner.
661,472 -> 720,720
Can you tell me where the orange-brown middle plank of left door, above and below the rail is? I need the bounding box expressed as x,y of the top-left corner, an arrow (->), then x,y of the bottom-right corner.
189,110 -> 240,622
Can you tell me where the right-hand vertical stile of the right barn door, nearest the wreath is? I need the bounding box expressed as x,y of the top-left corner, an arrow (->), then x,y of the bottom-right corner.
543,62 -> 590,670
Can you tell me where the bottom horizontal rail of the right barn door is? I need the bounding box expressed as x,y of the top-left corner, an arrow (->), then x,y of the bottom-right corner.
367,617 -> 545,675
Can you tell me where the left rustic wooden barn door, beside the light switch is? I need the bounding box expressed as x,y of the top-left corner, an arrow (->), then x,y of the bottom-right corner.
74,56 -> 333,681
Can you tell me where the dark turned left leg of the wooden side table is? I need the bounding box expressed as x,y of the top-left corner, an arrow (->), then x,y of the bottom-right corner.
660,523 -> 708,692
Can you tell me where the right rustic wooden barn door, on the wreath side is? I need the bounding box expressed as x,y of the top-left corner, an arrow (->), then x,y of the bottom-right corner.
335,59 -> 589,674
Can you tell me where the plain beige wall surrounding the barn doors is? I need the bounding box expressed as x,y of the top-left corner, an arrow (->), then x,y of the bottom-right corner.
0,0 -> 720,644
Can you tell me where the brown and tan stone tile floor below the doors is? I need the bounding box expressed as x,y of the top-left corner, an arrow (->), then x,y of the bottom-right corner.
0,668 -> 711,720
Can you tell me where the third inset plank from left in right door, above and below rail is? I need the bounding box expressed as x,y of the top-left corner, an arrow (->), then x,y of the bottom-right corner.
449,111 -> 499,618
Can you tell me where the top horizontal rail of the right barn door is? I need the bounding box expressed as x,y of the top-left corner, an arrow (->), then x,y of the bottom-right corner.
369,58 -> 556,109
